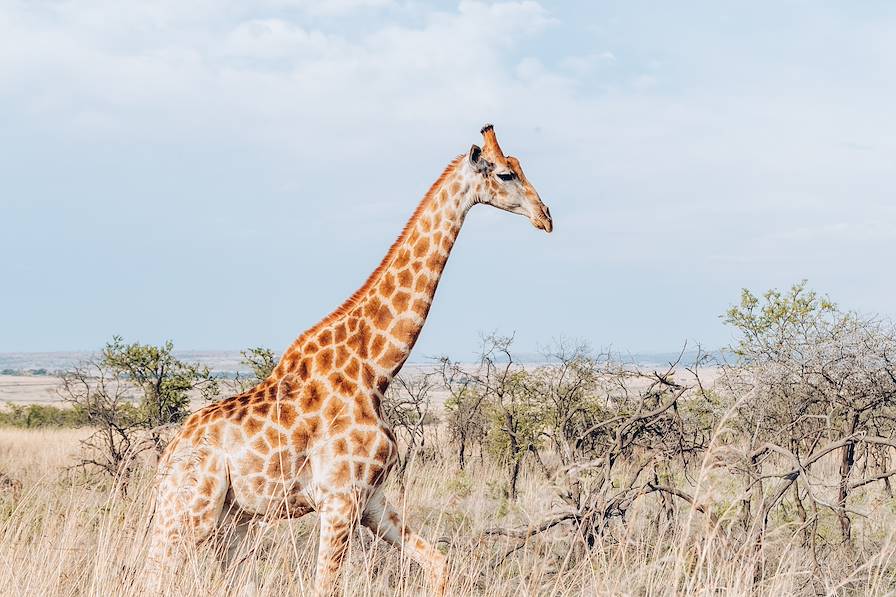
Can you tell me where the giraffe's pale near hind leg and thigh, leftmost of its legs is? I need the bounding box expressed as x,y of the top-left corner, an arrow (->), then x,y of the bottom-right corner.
146,449 -> 228,595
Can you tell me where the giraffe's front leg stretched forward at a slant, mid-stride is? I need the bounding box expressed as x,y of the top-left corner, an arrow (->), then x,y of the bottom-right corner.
361,490 -> 448,597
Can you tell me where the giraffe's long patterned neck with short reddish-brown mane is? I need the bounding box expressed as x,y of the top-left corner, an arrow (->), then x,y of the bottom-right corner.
273,157 -> 475,386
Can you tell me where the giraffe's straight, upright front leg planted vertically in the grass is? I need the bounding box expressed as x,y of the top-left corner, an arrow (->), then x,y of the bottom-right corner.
314,495 -> 358,597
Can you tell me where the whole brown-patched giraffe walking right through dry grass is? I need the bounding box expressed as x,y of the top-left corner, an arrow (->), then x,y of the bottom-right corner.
147,124 -> 553,597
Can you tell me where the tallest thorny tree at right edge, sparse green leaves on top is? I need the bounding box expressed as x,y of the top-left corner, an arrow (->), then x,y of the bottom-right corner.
725,282 -> 896,542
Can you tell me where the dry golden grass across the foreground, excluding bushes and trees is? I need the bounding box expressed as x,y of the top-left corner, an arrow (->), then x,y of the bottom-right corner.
0,430 -> 896,597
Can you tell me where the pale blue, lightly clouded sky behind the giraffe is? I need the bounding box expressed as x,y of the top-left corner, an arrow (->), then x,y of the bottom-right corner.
0,0 -> 896,360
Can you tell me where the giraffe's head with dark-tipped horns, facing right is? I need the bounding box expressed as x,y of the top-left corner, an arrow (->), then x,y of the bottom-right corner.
467,124 -> 554,232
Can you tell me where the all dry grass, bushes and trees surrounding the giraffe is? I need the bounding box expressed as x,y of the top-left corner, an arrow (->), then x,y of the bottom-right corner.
0,284 -> 896,596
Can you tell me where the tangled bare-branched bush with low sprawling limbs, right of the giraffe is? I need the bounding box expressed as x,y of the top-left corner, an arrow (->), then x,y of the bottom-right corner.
486,347 -> 716,559
